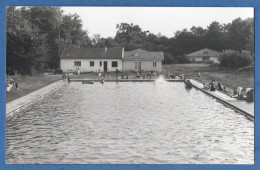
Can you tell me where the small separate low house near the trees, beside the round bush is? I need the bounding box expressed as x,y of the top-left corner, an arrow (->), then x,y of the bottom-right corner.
186,48 -> 221,63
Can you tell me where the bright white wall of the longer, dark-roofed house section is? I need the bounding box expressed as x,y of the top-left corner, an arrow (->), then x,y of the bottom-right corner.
60,59 -> 122,72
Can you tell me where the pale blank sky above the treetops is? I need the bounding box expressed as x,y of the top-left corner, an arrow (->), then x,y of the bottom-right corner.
62,7 -> 254,38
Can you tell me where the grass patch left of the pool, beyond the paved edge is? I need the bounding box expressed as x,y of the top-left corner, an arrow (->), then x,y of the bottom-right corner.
6,74 -> 61,103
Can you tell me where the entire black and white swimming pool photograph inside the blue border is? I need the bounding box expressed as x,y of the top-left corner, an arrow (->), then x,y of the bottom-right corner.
4,6 -> 255,165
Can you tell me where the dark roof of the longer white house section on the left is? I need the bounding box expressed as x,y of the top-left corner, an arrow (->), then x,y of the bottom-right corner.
60,47 -> 123,59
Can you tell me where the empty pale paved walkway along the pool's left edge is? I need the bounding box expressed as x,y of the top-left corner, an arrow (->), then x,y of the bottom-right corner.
6,80 -> 66,115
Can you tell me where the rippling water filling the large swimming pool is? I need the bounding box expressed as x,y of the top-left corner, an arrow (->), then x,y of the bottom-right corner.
6,81 -> 254,164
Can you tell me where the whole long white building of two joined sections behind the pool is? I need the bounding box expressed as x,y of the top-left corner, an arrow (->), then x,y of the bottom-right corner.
60,47 -> 164,72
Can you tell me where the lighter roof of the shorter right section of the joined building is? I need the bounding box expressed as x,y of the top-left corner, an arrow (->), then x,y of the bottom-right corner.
123,49 -> 164,61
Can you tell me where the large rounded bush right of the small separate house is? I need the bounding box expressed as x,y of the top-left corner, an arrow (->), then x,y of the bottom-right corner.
219,50 -> 253,68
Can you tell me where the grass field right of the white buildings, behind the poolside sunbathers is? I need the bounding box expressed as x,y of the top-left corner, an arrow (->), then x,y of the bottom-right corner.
163,64 -> 254,89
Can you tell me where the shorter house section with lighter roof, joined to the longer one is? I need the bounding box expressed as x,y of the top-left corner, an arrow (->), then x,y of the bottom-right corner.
123,49 -> 164,72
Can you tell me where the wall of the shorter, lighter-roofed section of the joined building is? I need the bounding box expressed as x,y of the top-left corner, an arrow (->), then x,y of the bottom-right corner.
123,61 -> 162,71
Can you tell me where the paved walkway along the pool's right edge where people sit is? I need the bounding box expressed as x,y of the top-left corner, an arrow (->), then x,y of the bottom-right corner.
191,80 -> 255,118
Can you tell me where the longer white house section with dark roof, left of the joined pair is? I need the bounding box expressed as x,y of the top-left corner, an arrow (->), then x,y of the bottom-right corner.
60,47 -> 124,72
